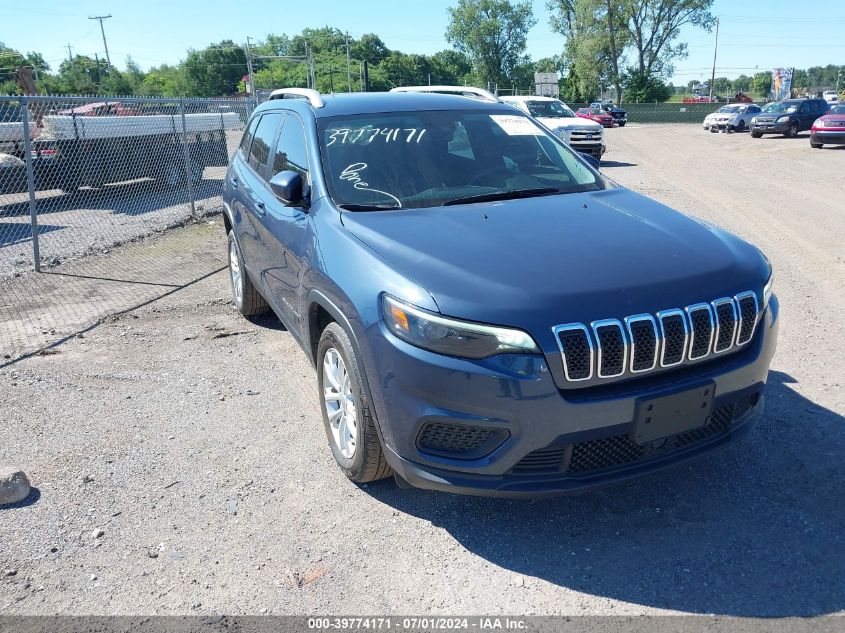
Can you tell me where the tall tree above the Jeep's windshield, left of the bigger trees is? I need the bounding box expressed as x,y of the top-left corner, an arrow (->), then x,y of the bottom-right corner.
446,0 -> 537,85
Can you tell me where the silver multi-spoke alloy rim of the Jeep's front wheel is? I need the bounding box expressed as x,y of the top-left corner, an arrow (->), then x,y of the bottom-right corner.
322,347 -> 358,459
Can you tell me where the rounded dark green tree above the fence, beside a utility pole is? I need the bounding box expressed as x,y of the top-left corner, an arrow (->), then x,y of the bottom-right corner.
182,40 -> 247,97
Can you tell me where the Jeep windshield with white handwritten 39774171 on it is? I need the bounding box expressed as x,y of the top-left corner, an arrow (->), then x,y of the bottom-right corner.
317,110 -> 605,210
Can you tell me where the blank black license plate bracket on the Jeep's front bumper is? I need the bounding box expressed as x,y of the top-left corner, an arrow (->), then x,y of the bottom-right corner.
631,382 -> 716,444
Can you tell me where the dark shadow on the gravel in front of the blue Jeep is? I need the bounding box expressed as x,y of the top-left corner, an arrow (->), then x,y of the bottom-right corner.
368,372 -> 845,616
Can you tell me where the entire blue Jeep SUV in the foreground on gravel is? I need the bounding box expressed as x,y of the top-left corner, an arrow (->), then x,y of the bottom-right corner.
224,89 -> 778,496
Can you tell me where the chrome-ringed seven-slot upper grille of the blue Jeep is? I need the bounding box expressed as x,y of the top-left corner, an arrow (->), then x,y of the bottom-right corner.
553,291 -> 760,382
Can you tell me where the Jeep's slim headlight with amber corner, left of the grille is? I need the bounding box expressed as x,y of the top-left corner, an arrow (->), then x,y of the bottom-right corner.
382,295 -> 540,358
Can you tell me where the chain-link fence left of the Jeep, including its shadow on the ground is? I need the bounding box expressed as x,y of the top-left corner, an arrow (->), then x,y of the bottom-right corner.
0,97 -> 255,365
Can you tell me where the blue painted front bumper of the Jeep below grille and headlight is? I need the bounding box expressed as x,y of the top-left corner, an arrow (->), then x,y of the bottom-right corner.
363,297 -> 778,496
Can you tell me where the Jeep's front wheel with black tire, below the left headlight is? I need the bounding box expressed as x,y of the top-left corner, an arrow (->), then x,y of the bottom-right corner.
317,323 -> 393,483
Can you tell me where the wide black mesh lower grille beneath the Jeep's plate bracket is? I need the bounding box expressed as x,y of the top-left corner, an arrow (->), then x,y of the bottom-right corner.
511,393 -> 760,474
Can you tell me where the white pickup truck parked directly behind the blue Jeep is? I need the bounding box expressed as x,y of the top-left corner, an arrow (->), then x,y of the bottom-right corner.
499,96 -> 607,161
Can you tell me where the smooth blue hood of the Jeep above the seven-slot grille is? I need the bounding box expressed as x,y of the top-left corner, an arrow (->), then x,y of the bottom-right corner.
343,187 -> 768,332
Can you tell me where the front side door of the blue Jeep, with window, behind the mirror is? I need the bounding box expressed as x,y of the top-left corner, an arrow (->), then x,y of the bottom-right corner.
260,112 -> 311,332
